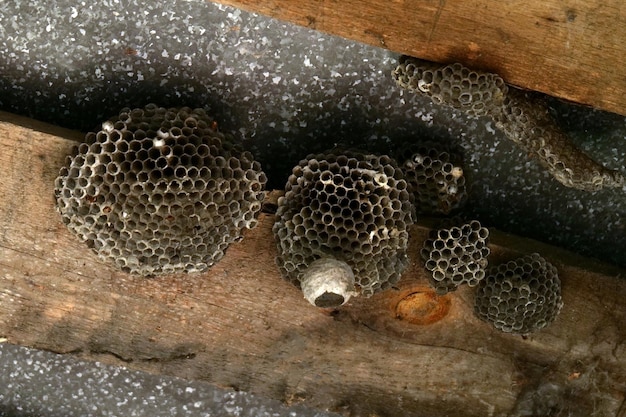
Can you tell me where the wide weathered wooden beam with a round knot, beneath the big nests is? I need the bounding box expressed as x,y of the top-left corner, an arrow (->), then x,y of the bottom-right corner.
0,109 -> 626,417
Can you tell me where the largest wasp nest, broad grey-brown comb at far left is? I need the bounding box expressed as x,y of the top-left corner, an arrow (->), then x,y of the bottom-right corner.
55,105 -> 266,275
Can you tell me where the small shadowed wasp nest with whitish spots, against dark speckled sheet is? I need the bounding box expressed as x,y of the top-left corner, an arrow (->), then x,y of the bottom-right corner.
402,147 -> 467,215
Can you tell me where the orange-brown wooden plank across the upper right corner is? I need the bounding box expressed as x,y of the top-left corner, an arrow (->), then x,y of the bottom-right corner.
208,0 -> 626,115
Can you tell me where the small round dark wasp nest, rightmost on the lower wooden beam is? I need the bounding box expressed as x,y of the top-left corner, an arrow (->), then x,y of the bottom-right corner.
474,253 -> 563,334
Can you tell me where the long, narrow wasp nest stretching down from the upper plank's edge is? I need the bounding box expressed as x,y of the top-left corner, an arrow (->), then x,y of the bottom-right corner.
392,56 -> 625,191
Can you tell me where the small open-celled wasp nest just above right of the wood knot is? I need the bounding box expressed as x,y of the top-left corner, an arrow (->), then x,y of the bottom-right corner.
420,220 -> 490,295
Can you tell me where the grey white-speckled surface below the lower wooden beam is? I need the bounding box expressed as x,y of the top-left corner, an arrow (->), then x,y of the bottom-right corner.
0,344 -> 338,417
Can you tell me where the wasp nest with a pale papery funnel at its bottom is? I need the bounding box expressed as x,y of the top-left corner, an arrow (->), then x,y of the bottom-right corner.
273,152 -> 414,307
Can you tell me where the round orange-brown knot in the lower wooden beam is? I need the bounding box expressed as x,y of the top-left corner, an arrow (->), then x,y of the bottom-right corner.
396,289 -> 450,325
